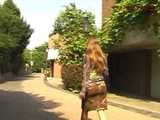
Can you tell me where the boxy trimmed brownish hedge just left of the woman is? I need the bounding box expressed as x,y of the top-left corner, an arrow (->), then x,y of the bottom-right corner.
61,64 -> 83,91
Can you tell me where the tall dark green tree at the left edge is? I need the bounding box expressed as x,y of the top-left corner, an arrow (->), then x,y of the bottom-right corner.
0,0 -> 33,73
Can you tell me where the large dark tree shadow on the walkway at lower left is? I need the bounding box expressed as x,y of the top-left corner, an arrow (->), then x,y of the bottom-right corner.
0,90 -> 68,120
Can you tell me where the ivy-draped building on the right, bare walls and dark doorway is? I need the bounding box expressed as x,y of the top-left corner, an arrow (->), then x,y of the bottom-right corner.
102,0 -> 160,98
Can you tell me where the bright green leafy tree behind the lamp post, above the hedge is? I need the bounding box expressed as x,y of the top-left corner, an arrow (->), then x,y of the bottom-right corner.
53,4 -> 97,64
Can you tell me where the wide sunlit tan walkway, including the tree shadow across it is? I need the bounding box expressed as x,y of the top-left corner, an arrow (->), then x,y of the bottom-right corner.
0,74 -> 158,120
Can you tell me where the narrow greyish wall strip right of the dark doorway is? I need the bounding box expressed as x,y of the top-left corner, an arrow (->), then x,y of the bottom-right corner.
151,51 -> 160,98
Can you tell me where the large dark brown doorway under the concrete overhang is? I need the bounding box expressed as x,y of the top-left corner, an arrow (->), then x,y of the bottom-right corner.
109,50 -> 151,96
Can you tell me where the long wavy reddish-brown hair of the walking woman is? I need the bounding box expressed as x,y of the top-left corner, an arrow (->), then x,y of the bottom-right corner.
86,37 -> 107,73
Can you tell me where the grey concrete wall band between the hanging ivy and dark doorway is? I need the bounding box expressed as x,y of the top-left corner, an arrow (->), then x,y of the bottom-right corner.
112,29 -> 160,52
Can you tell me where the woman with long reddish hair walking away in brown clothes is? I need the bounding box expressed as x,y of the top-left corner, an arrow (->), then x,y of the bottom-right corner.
80,37 -> 108,120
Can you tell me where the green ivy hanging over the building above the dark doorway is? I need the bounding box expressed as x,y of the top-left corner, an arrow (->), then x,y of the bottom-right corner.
100,0 -> 160,50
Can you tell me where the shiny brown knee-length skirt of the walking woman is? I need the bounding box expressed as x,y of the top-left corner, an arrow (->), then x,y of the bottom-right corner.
82,80 -> 107,111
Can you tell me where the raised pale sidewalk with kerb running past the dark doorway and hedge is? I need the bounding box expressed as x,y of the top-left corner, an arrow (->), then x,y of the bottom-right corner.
45,78 -> 160,119
